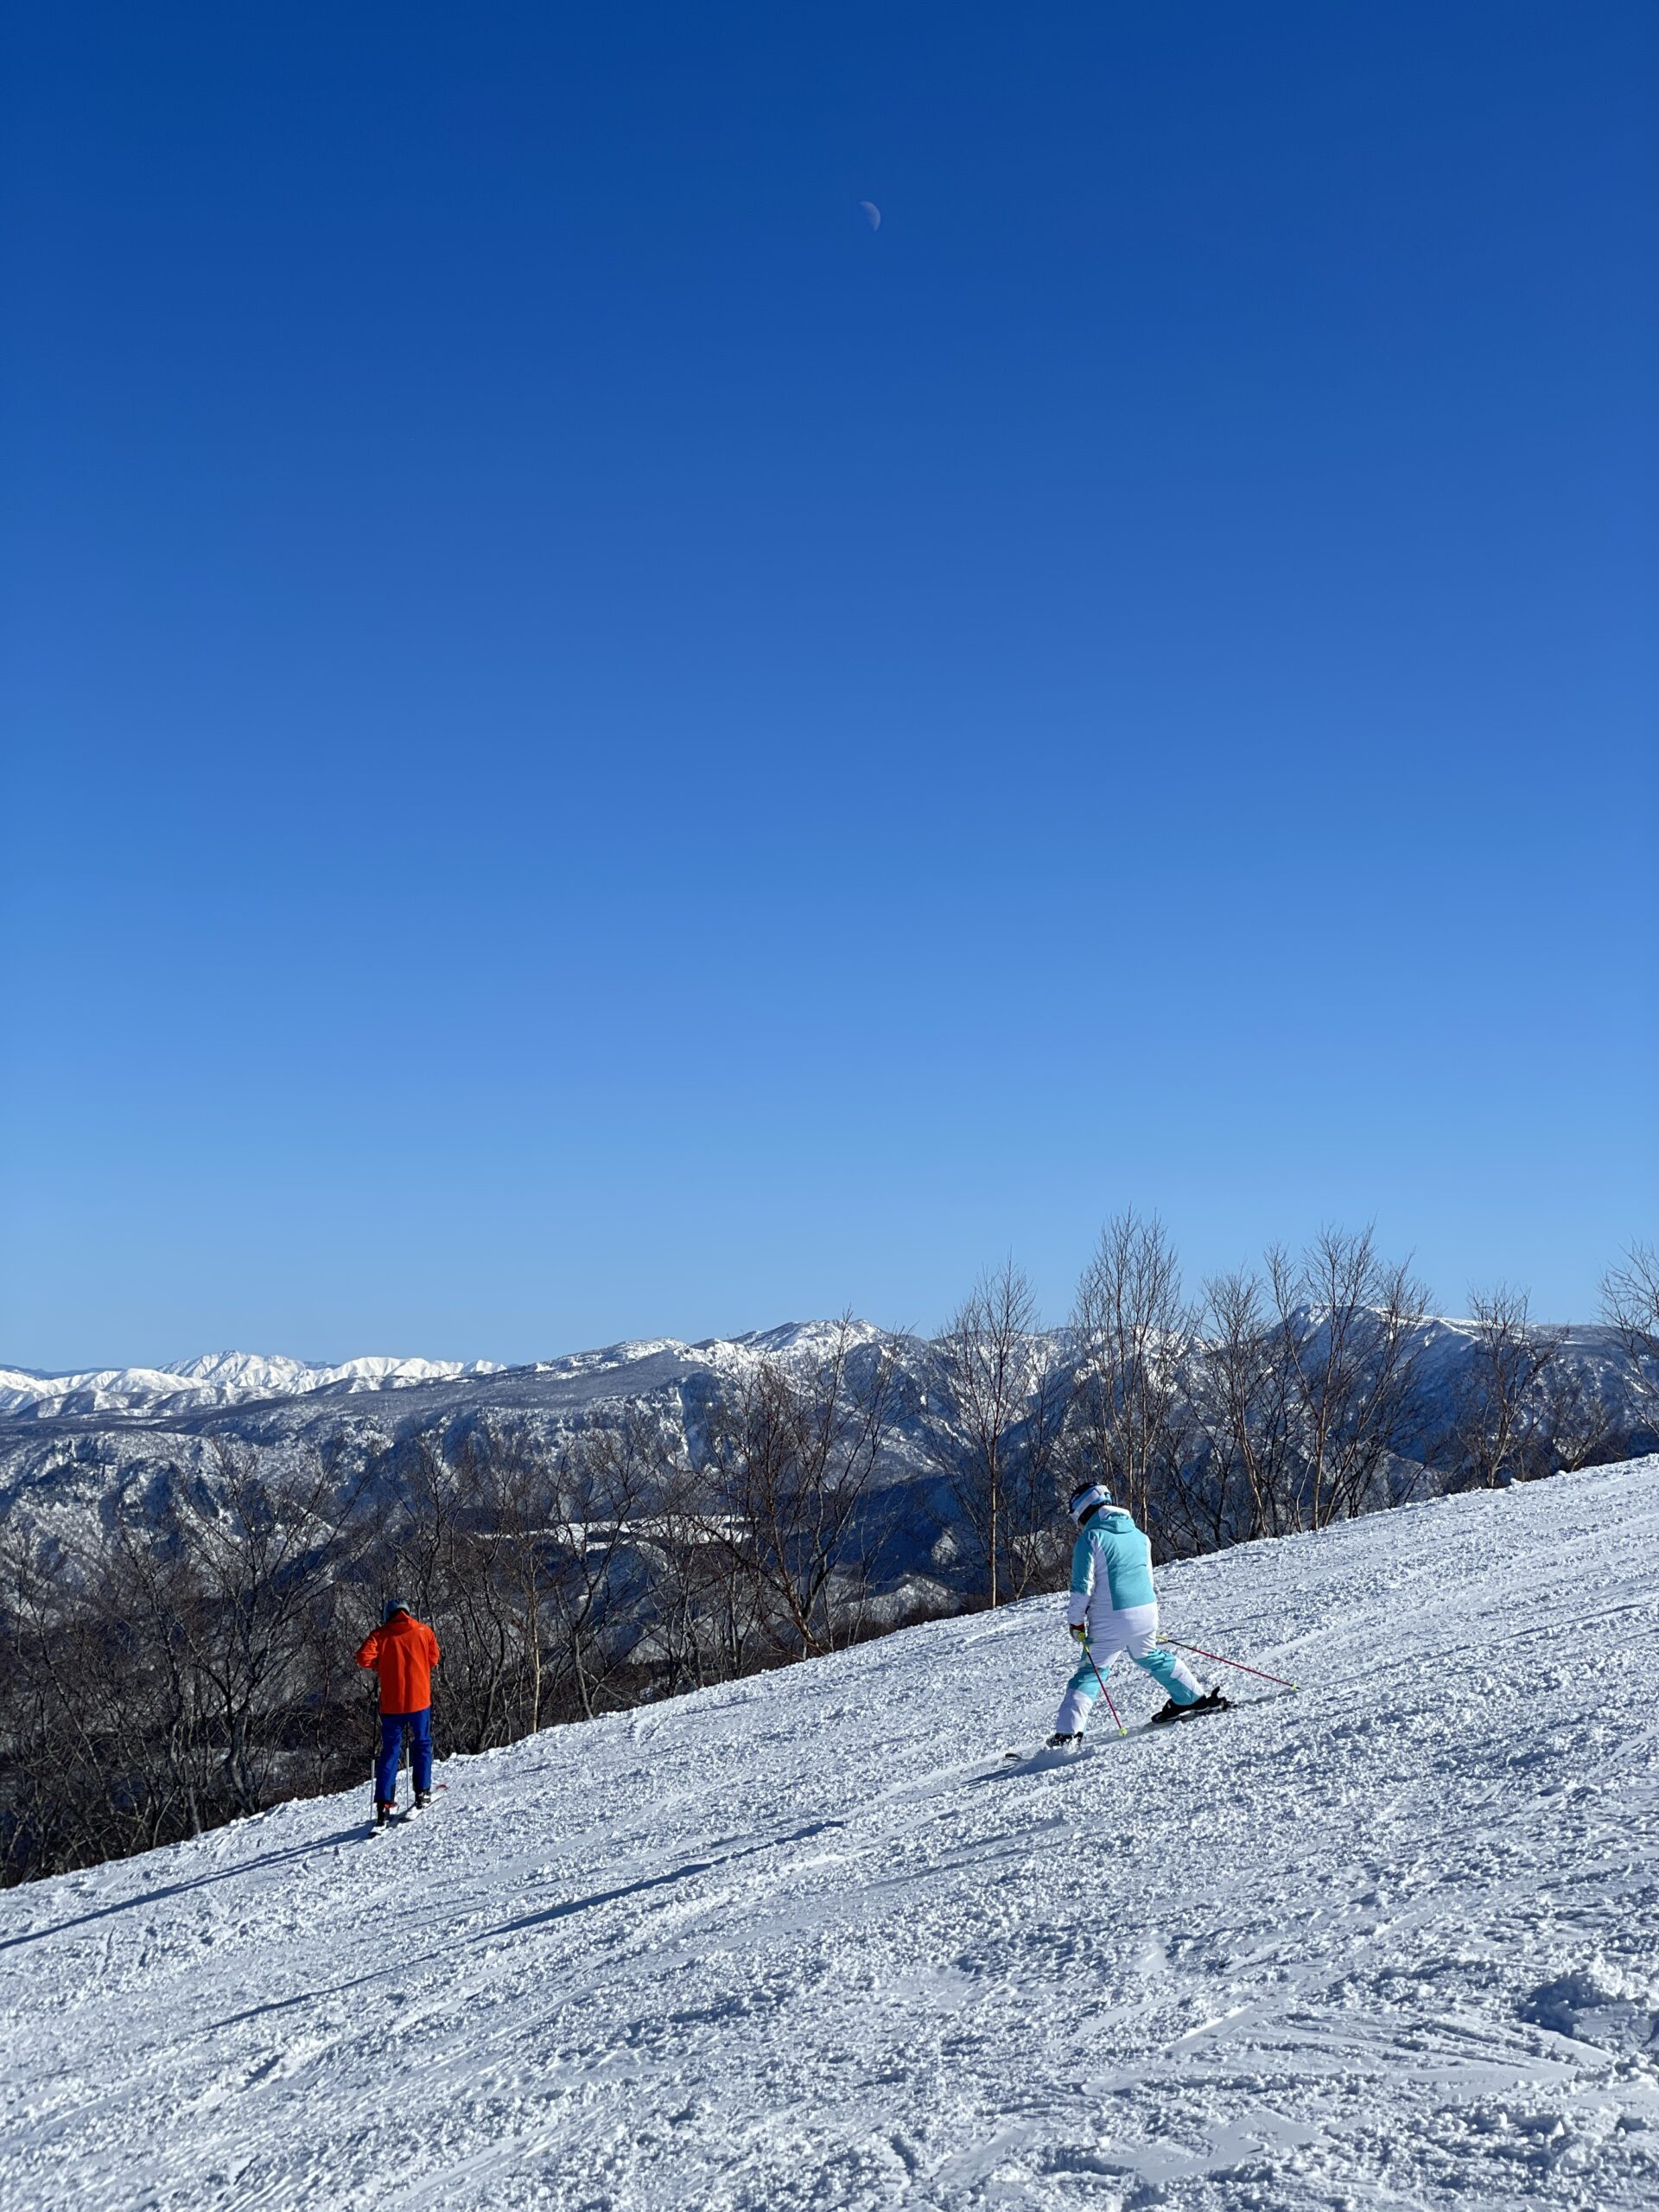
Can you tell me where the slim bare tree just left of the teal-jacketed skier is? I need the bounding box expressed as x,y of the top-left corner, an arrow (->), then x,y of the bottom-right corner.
927,1261 -> 1062,1606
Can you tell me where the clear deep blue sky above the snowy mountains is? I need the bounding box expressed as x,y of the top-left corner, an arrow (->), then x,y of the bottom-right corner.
0,0 -> 1659,1367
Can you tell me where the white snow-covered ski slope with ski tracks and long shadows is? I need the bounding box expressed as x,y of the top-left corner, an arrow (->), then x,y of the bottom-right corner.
0,1460 -> 1659,2212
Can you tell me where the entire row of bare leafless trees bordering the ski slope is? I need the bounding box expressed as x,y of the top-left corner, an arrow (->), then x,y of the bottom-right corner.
0,1247 -> 1659,1883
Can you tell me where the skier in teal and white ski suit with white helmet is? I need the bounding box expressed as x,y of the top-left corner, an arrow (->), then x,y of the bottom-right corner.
1048,1482 -> 1225,1750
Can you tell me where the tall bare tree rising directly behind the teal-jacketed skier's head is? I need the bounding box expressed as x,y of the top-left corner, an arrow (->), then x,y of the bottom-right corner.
1071,1212 -> 1192,1529
